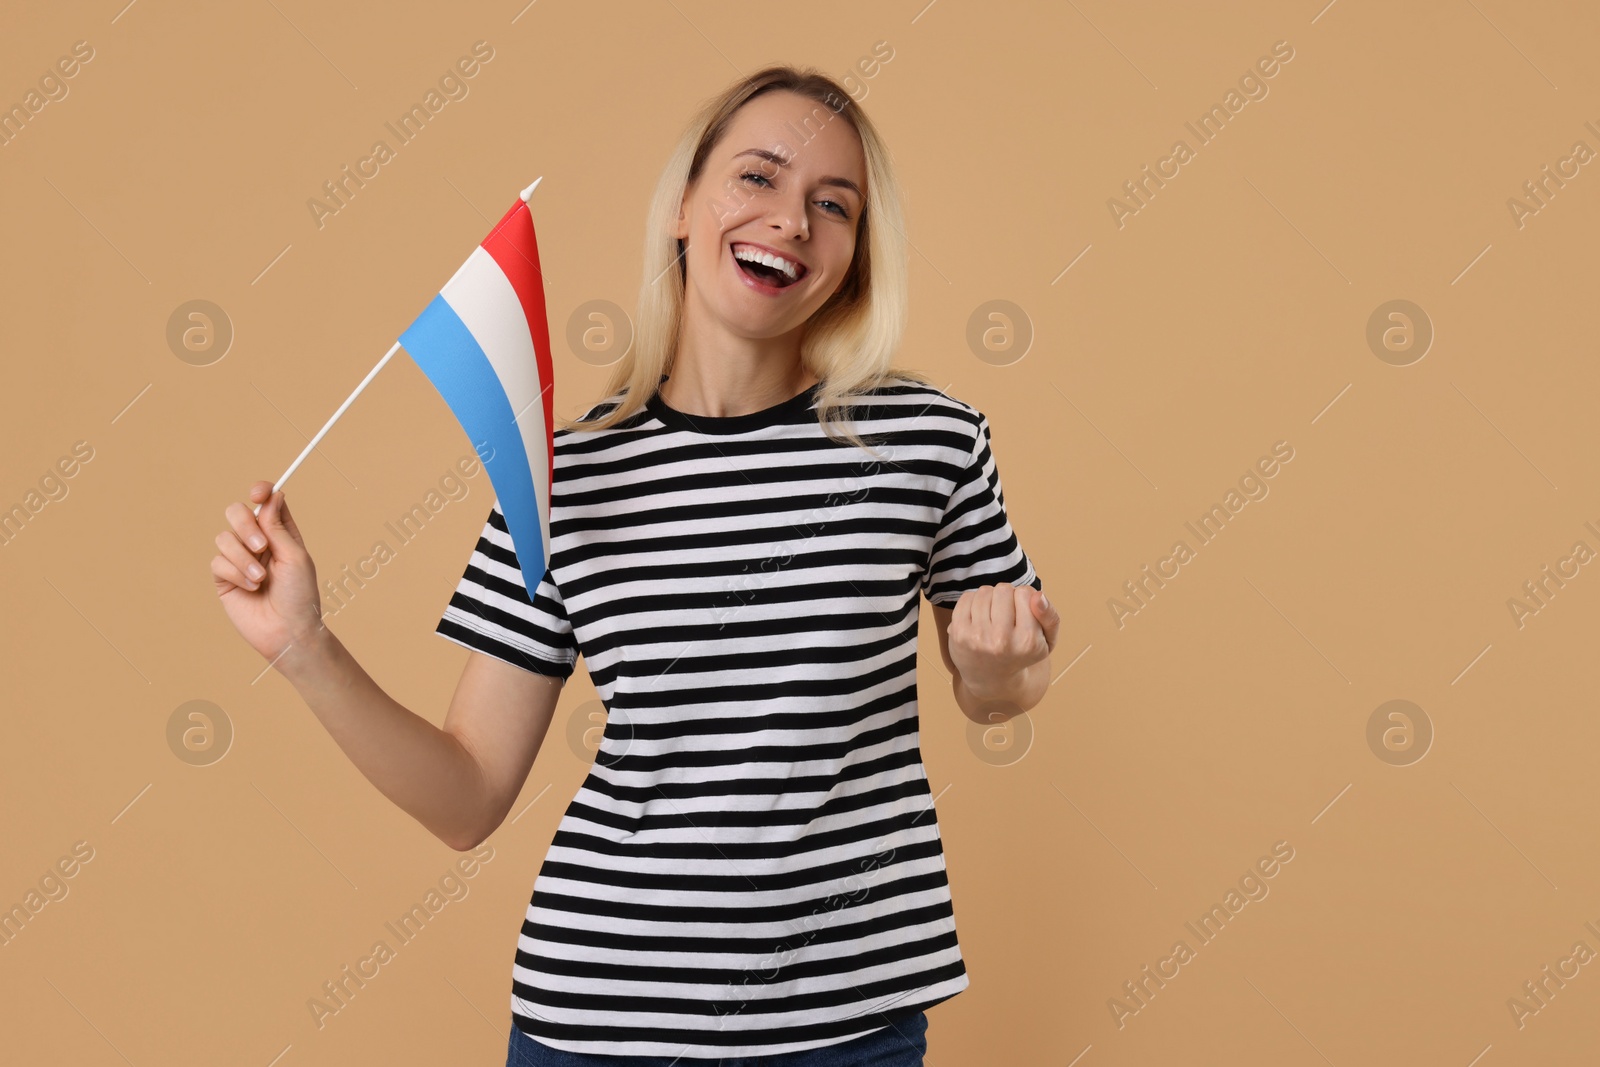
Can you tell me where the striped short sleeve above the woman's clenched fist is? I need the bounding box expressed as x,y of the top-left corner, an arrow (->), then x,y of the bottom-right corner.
922,414 -> 1045,608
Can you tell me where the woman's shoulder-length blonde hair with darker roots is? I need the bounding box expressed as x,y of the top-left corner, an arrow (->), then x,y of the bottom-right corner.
562,66 -> 933,448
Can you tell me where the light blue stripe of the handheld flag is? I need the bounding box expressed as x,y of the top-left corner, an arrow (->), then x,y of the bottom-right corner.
400,296 -> 549,600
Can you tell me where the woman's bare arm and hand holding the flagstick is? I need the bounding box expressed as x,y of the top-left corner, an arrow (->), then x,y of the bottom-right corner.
211,482 -> 565,851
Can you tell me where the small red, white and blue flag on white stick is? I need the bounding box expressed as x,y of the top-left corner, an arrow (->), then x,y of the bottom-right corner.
256,179 -> 555,598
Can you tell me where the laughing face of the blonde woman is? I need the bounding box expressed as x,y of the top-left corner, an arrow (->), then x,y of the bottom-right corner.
674,91 -> 867,338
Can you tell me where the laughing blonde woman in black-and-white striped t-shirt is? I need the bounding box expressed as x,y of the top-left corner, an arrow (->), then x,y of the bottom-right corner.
213,67 -> 1059,1067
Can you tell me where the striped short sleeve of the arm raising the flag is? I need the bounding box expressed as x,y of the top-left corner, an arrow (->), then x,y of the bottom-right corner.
434,499 -> 578,678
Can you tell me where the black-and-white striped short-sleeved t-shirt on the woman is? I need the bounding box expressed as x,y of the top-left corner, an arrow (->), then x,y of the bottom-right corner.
437,378 -> 1043,1059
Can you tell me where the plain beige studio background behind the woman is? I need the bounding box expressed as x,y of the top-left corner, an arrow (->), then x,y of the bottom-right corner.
0,0 -> 1600,1067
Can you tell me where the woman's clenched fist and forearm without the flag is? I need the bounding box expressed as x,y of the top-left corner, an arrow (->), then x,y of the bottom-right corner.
933,582 -> 1061,726
